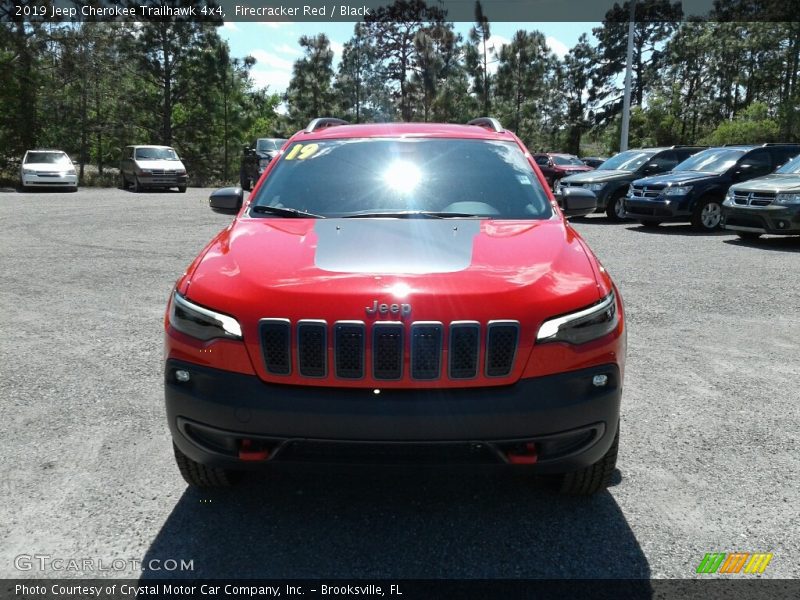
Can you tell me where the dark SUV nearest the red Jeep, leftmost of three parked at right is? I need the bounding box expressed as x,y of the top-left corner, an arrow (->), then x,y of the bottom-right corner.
556,146 -> 706,221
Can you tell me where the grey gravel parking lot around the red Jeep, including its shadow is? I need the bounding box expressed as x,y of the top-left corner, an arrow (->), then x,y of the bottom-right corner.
0,189 -> 800,578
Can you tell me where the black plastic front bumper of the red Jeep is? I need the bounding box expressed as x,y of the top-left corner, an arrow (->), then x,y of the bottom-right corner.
165,360 -> 622,472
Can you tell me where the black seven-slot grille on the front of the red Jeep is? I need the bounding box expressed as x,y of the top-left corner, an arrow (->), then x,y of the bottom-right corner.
259,319 -> 519,381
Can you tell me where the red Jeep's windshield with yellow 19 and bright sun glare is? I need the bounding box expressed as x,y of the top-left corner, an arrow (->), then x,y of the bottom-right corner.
251,138 -> 552,219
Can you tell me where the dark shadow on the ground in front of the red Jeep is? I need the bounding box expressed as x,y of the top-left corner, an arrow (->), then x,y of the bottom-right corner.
144,465 -> 650,584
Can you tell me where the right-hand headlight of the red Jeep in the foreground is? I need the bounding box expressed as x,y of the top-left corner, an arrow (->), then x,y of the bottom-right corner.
536,292 -> 619,344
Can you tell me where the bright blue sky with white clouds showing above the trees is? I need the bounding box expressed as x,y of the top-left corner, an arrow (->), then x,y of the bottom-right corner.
219,21 -> 599,93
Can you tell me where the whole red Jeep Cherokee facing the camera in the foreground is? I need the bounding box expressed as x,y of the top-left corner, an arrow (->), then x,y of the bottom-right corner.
165,118 -> 625,494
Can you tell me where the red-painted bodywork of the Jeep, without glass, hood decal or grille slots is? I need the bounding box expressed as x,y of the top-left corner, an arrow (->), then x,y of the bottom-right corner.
166,124 -> 625,388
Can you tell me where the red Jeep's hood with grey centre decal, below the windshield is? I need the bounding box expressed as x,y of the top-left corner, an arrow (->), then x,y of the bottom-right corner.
180,217 -> 608,376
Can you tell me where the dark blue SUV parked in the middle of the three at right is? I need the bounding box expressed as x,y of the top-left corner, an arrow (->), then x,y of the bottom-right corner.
624,144 -> 800,231
